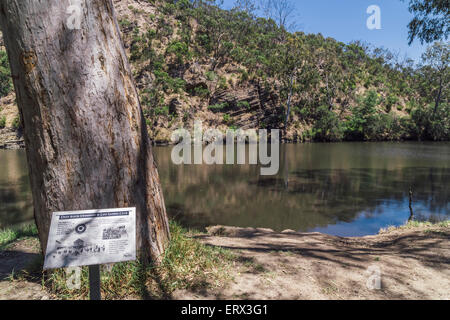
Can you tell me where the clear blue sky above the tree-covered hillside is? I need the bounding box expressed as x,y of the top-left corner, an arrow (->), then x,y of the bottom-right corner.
224,0 -> 426,62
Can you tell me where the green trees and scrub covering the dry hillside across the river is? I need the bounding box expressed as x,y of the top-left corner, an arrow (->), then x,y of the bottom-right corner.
0,0 -> 450,141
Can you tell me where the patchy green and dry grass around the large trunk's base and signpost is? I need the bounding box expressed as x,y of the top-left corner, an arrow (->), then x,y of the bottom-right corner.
0,222 -> 235,300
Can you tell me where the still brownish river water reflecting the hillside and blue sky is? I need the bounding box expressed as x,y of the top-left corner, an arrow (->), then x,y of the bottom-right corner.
0,143 -> 450,236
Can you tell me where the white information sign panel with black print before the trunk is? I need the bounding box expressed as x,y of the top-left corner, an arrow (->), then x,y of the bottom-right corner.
44,208 -> 136,269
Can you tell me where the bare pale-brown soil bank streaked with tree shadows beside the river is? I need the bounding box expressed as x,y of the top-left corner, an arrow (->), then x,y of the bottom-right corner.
0,226 -> 450,299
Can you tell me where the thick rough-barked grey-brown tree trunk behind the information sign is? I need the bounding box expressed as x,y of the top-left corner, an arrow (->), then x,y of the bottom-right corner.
0,0 -> 169,261
